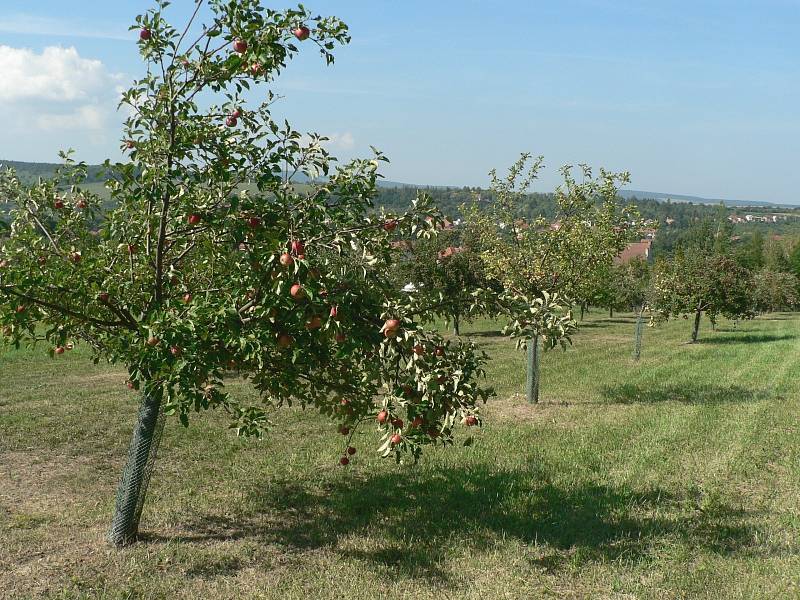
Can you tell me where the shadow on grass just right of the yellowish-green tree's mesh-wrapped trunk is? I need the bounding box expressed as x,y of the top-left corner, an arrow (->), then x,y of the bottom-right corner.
600,383 -> 768,404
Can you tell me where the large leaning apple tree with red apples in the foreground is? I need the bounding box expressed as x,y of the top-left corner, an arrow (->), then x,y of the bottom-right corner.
0,0 -> 491,545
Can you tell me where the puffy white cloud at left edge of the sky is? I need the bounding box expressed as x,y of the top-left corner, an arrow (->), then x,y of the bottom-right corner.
0,45 -> 122,132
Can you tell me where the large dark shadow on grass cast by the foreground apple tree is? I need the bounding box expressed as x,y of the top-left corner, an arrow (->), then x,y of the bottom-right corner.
144,465 -> 756,584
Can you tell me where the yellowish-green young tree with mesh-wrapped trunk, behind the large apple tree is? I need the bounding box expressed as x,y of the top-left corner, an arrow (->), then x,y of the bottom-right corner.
468,154 -> 639,402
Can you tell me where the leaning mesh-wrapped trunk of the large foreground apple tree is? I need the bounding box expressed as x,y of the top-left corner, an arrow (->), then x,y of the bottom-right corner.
108,395 -> 164,546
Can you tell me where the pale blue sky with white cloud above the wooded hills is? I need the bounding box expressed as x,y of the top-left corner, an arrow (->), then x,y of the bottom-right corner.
0,0 -> 800,203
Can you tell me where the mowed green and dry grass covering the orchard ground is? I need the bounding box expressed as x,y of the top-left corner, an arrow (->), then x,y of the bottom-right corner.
0,313 -> 800,599
